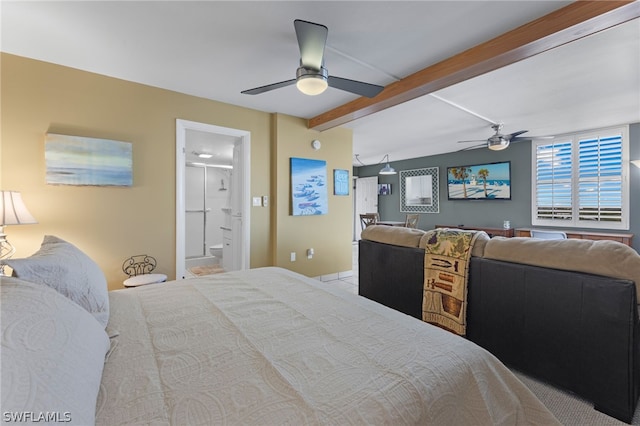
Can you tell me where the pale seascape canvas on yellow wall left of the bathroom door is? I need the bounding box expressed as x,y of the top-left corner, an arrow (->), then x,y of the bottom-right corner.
44,133 -> 133,186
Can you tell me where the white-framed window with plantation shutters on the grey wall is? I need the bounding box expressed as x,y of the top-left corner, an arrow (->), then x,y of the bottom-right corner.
531,126 -> 629,229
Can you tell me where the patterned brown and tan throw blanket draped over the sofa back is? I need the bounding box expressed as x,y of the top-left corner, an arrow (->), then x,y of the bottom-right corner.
422,228 -> 479,336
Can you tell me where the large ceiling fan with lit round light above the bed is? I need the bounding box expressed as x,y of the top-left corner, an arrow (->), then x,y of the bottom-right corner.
241,19 -> 384,98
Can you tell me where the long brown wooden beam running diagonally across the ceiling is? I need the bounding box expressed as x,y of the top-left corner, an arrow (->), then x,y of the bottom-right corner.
308,0 -> 640,131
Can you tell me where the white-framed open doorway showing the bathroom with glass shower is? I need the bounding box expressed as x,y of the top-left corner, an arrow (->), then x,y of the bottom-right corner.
176,119 -> 250,279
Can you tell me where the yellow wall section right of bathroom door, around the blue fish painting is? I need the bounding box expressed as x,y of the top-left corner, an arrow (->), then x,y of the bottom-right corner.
274,115 -> 353,276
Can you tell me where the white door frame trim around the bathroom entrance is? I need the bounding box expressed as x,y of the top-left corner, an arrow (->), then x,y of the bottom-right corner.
176,119 -> 251,280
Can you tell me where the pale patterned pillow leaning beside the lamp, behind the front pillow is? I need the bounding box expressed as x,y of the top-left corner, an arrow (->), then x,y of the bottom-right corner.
2,235 -> 109,327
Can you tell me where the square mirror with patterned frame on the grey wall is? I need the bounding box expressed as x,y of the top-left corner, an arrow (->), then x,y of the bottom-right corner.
400,167 -> 440,213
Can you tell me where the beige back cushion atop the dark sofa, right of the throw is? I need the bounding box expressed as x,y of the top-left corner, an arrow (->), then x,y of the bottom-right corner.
484,237 -> 640,303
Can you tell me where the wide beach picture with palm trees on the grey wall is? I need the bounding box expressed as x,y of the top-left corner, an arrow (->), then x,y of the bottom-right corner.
447,161 -> 511,200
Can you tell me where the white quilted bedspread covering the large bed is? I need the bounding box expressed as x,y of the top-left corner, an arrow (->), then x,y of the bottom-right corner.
96,268 -> 558,425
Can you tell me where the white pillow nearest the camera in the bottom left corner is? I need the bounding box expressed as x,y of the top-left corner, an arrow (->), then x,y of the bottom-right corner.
0,277 -> 109,425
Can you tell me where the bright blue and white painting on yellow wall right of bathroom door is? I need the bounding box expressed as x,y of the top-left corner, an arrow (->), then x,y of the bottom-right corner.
291,157 -> 329,216
